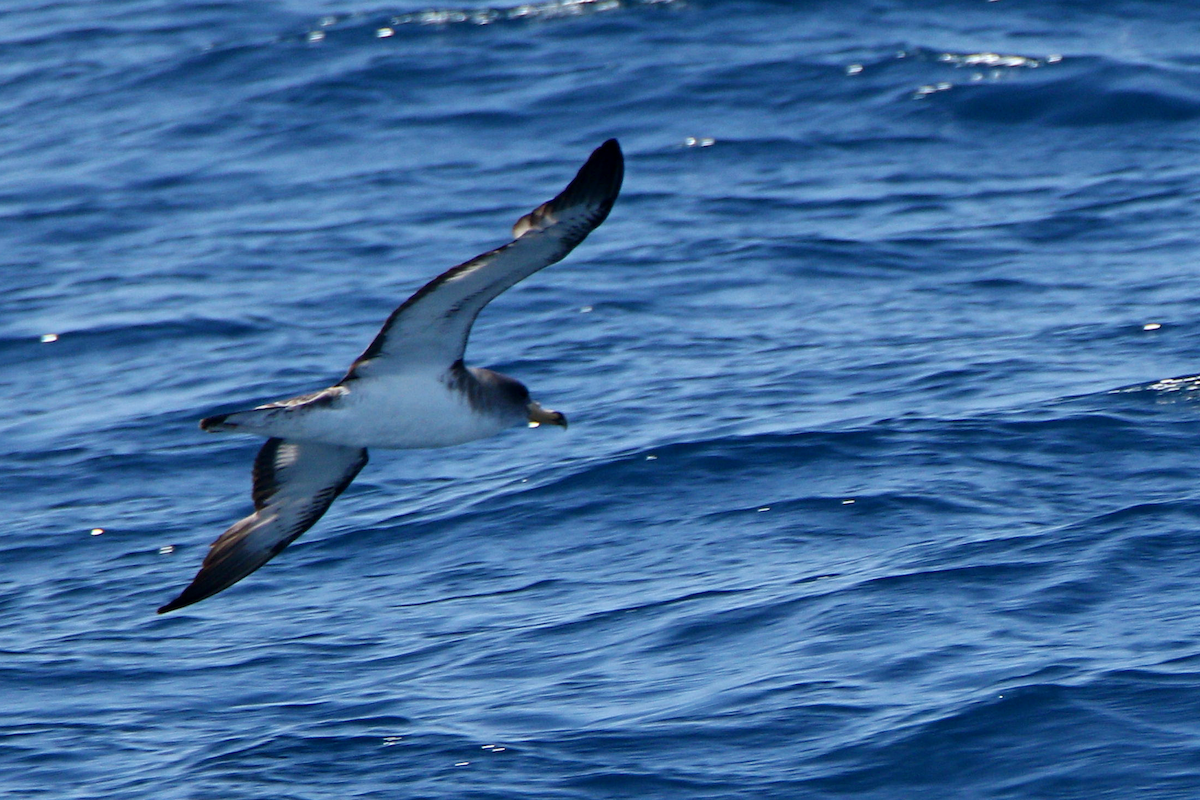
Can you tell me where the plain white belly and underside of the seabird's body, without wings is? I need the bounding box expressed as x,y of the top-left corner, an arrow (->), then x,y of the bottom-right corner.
230,372 -> 522,450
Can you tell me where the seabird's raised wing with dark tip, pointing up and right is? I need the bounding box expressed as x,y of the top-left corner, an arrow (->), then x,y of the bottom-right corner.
343,139 -> 625,381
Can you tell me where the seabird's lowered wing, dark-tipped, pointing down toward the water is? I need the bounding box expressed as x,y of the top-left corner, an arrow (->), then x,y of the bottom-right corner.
158,439 -> 367,614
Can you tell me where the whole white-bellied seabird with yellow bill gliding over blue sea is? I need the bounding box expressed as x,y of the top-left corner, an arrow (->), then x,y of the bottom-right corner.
158,139 -> 625,614
